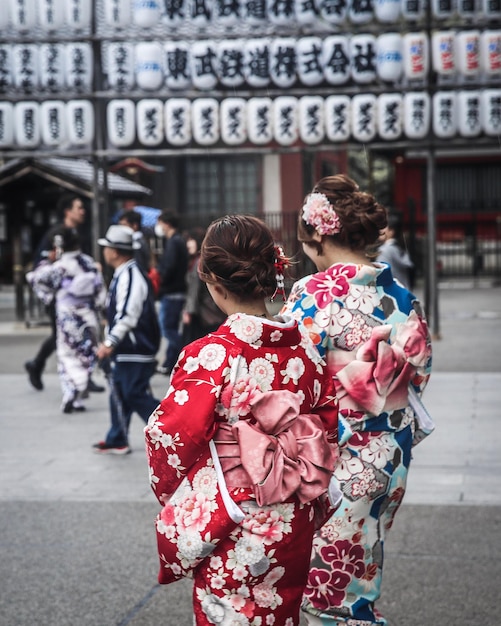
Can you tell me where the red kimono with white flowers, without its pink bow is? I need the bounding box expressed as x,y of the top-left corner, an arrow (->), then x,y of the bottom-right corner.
145,314 -> 337,626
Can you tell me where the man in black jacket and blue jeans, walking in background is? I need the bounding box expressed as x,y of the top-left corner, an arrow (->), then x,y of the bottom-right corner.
158,212 -> 188,376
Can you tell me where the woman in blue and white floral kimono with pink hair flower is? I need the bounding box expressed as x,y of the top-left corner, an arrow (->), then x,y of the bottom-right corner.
285,175 -> 433,626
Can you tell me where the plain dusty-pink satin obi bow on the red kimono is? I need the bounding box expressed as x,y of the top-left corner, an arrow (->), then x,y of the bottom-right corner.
214,390 -> 337,506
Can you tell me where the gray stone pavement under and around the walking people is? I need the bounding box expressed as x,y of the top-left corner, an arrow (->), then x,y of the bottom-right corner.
0,281 -> 501,626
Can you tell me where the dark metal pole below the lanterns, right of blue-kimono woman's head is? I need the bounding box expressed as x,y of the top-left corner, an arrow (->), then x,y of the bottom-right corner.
426,148 -> 440,339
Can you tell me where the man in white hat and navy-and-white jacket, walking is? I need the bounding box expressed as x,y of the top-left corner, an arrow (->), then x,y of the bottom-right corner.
94,226 -> 160,454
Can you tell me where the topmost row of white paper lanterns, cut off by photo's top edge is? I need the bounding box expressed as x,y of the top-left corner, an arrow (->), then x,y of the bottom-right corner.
4,0 -> 501,32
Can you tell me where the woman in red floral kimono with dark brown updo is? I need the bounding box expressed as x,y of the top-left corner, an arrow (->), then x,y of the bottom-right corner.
145,216 -> 337,626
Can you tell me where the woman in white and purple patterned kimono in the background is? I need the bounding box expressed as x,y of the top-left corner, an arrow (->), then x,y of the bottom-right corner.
27,227 -> 106,413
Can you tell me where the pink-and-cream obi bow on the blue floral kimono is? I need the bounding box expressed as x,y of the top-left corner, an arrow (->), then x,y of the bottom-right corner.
327,311 -> 430,415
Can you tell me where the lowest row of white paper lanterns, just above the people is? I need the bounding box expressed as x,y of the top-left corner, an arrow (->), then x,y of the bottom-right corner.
0,89 -> 501,149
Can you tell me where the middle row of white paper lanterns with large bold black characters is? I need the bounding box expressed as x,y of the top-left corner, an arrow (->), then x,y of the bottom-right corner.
0,30 -> 501,92
